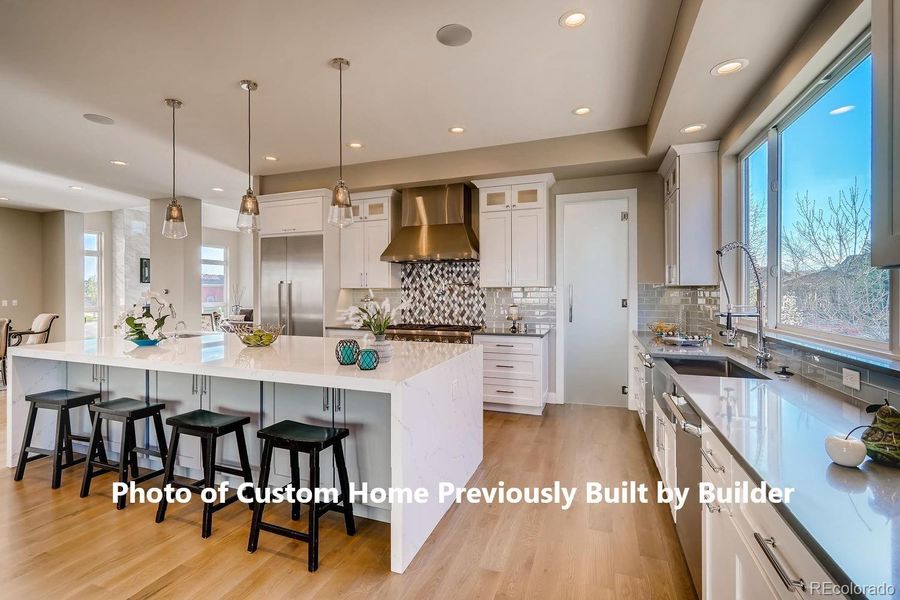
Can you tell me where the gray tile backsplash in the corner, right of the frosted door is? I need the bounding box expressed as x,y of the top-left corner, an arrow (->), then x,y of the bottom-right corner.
638,283 -> 719,335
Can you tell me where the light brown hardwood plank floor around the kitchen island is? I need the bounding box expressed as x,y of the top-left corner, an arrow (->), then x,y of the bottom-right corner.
0,392 -> 695,600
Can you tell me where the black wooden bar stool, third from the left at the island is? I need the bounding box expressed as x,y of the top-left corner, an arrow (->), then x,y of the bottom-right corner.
156,409 -> 253,538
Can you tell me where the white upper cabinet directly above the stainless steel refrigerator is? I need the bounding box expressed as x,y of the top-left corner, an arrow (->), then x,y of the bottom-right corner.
259,189 -> 330,237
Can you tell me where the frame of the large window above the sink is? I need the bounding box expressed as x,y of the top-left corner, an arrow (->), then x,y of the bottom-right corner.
737,30 -> 884,353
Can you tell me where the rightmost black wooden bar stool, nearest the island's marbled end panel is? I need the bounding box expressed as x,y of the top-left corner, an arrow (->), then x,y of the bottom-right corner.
247,421 -> 356,572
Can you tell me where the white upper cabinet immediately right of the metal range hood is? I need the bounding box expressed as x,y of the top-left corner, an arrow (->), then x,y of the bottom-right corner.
472,173 -> 555,287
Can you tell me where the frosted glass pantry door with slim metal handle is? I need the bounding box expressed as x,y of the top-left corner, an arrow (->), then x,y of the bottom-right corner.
558,197 -> 628,407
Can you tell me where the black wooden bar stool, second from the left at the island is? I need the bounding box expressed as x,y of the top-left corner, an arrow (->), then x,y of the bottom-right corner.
81,398 -> 166,510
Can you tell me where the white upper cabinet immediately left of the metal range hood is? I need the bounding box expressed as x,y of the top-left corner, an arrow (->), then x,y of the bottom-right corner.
341,190 -> 400,288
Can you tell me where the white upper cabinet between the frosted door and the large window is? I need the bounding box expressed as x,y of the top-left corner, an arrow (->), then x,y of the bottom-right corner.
659,142 -> 719,285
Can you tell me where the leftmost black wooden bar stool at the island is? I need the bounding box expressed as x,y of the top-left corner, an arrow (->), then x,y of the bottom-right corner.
13,390 -> 106,489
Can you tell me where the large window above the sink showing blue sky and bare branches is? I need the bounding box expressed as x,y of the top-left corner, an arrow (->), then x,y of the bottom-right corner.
741,34 -> 890,349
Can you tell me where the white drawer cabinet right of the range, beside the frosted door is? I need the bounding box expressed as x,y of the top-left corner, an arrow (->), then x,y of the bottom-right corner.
475,335 -> 549,415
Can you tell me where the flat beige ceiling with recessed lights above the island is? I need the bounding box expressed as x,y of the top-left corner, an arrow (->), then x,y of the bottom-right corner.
0,0 -> 680,211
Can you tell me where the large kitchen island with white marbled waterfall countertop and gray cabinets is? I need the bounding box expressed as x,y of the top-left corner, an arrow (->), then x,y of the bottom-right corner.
6,334 -> 483,573
